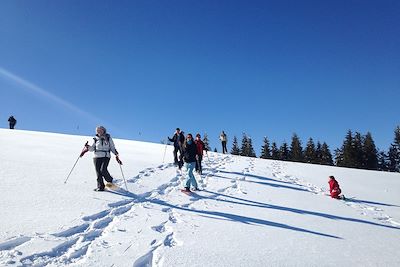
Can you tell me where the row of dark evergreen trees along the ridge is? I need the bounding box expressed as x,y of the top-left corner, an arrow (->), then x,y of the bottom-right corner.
219,126 -> 400,172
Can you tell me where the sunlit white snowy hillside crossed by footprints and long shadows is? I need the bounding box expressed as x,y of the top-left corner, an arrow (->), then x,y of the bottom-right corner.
0,129 -> 400,267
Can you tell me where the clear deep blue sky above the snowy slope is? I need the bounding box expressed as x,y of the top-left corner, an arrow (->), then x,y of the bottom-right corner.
0,0 -> 400,155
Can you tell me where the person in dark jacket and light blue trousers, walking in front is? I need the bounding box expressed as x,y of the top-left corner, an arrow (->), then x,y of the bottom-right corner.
183,134 -> 199,192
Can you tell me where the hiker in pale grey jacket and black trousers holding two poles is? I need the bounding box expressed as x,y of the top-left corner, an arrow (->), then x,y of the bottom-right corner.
81,126 -> 122,191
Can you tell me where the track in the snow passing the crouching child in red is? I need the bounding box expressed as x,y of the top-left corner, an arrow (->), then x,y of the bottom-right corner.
272,161 -> 400,227
